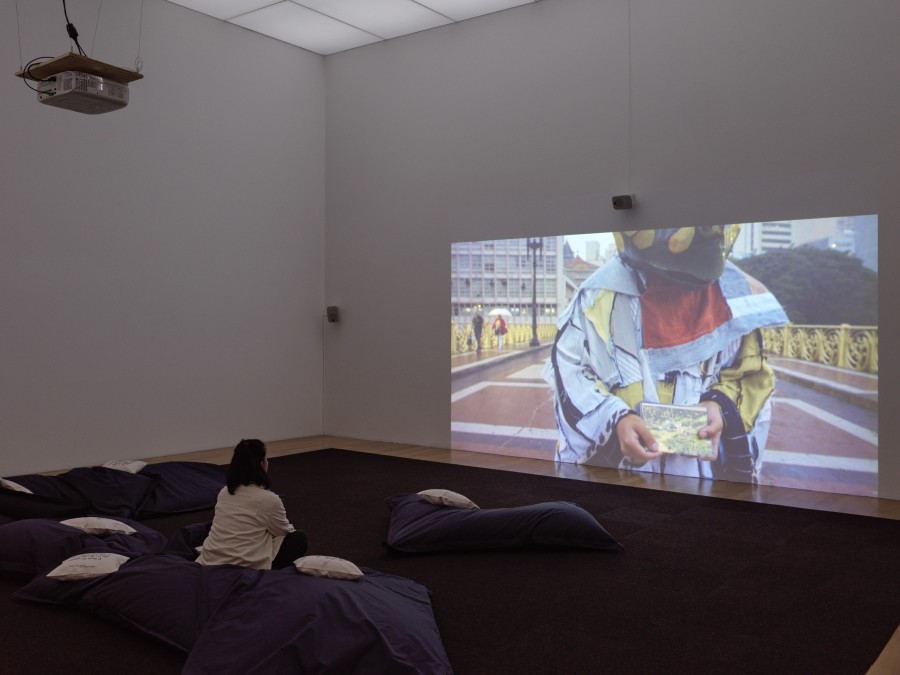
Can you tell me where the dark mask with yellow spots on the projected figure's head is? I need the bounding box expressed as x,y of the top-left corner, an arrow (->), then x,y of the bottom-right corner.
613,225 -> 741,288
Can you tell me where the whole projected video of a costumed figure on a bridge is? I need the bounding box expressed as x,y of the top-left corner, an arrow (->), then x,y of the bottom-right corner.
451,215 -> 878,496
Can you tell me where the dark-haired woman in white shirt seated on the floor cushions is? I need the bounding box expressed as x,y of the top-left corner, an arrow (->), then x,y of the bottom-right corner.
197,439 -> 307,569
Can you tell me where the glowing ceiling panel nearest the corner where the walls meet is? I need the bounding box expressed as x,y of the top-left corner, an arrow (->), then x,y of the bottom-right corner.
229,2 -> 381,55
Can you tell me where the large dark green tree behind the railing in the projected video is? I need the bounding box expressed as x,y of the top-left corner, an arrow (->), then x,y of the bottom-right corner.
734,246 -> 878,326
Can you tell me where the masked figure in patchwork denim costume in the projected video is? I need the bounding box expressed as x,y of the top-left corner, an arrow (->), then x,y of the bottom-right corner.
544,225 -> 787,482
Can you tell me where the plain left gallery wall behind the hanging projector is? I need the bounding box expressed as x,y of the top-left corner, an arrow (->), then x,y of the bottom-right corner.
0,0 -> 325,475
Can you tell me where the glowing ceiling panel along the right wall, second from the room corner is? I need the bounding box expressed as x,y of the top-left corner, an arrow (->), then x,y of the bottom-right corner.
293,0 -> 453,39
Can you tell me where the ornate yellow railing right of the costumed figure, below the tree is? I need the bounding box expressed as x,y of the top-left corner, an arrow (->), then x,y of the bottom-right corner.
763,323 -> 878,374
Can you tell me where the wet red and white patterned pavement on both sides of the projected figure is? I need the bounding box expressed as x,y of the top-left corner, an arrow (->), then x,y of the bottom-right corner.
450,341 -> 878,496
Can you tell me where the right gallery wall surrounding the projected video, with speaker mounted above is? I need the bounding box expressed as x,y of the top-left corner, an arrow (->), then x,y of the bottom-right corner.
325,0 -> 900,498
